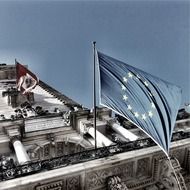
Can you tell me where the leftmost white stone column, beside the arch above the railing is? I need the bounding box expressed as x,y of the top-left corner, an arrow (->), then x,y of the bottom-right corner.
12,137 -> 30,164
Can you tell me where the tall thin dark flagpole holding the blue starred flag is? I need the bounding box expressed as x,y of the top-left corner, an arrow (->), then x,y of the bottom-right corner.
93,41 -> 97,149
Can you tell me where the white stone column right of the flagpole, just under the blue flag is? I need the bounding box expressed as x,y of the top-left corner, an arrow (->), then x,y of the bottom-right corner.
110,123 -> 138,141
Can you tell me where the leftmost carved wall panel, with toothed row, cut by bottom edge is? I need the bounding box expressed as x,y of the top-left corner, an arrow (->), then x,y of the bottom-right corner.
35,181 -> 63,190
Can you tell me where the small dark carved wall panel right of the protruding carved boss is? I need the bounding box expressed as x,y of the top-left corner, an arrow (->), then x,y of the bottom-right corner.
136,158 -> 150,177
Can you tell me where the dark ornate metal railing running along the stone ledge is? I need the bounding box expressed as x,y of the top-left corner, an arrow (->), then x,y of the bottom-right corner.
0,131 -> 190,181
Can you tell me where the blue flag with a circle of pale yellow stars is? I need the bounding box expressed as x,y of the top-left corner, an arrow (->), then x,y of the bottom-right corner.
97,52 -> 181,154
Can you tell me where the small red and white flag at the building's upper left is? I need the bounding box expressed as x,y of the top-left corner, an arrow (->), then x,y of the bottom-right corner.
15,60 -> 39,94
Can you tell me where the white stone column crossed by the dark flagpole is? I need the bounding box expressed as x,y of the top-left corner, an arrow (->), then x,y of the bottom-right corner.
87,127 -> 113,147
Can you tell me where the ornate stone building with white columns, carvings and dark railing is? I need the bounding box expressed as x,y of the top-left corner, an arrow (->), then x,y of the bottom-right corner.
0,64 -> 190,190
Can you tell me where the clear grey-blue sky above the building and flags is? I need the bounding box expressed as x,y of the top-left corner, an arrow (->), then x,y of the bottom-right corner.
0,0 -> 190,108
